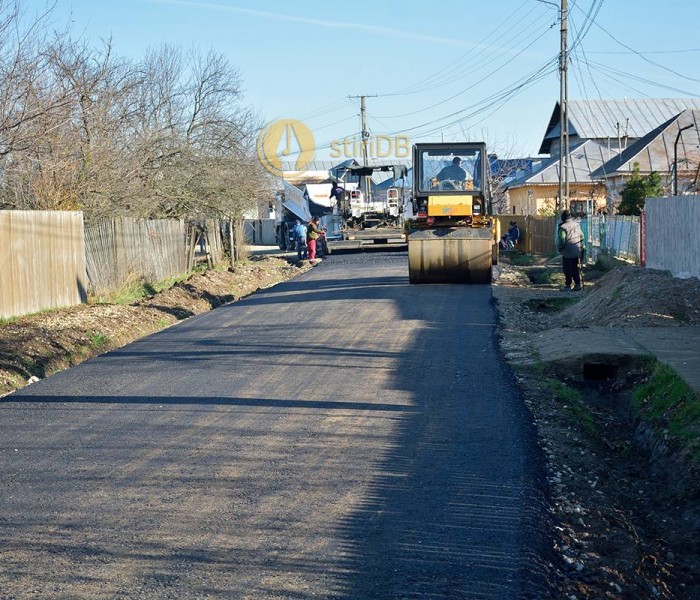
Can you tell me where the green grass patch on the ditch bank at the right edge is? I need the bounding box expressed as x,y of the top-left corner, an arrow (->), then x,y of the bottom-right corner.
633,363 -> 700,465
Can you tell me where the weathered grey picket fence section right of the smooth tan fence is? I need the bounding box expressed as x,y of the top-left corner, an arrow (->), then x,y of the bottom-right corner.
85,218 -> 188,293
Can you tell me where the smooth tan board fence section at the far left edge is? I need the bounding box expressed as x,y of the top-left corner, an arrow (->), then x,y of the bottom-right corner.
0,210 -> 87,318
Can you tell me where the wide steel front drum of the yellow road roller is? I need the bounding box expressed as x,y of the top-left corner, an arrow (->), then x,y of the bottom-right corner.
408,227 -> 493,283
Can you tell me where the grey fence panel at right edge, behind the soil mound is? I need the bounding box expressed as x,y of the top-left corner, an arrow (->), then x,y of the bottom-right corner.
645,196 -> 700,278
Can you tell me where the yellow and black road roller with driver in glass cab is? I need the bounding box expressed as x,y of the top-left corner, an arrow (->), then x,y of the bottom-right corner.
406,142 -> 499,283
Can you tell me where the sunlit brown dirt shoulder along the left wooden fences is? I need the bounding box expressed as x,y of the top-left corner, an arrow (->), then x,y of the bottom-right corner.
0,256 -> 311,397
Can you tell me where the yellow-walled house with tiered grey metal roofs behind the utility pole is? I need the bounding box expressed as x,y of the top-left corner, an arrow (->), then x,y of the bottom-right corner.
505,98 -> 700,214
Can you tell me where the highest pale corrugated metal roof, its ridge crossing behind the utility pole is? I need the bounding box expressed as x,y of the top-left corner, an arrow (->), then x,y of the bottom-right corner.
540,98 -> 700,154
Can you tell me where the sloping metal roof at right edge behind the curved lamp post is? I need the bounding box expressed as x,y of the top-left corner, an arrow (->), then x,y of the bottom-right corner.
591,110 -> 700,179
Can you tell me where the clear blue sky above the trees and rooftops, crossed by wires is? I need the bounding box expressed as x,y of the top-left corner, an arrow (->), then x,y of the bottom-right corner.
23,0 -> 700,158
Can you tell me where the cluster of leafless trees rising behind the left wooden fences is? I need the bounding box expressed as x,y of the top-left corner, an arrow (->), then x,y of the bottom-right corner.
0,14 -> 270,223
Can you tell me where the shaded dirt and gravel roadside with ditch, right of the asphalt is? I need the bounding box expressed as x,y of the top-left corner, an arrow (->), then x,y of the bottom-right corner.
493,255 -> 700,599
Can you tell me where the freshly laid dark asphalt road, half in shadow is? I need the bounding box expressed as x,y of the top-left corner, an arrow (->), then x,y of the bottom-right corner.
0,253 -> 548,600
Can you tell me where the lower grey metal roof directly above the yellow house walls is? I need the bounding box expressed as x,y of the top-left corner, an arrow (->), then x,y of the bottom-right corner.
505,140 -> 617,189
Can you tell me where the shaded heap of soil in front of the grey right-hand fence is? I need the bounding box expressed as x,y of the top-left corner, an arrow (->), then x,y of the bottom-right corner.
555,266 -> 700,327
